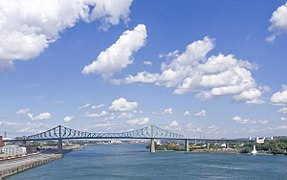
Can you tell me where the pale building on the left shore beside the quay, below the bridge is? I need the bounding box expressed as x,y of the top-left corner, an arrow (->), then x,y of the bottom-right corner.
0,145 -> 27,157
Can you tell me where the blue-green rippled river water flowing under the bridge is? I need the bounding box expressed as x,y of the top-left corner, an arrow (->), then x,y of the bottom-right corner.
5,144 -> 287,180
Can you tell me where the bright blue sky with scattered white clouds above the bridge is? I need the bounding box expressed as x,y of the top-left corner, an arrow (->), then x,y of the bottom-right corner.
0,0 -> 287,138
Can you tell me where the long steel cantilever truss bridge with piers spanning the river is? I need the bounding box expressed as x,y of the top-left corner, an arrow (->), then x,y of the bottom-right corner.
4,125 -> 254,152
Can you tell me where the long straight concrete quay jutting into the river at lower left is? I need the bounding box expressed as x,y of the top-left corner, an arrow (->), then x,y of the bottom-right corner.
0,153 -> 63,180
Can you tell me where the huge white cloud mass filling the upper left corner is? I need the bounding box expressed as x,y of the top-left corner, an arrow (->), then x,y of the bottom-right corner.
0,0 -> 132,71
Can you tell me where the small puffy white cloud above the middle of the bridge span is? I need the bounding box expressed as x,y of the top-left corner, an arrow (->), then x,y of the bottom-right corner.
109,98 -> 138,111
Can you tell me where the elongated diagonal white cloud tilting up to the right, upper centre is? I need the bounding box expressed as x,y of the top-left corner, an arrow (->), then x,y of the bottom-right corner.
82,24 -> 147,79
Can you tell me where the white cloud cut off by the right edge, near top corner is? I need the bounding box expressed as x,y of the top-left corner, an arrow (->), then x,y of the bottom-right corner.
266,2 -> 287,42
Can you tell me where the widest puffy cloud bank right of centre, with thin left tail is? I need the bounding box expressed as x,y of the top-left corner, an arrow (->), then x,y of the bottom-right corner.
117,37 -> 263,104
